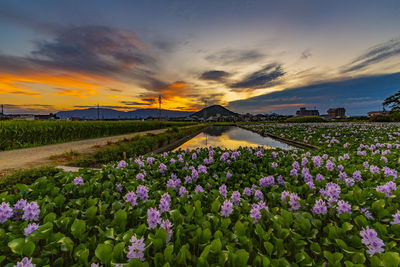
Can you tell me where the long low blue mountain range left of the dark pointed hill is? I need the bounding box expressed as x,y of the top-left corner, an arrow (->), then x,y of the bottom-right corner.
56,108 -> 193,120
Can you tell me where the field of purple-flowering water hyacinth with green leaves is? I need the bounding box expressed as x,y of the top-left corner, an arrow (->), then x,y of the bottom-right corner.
0,123 -> 400,266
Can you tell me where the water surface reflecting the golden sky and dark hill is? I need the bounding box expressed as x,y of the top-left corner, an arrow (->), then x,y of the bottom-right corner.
174,126 -> 293,151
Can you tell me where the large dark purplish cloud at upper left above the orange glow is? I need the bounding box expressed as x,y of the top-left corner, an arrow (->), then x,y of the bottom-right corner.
31,26 -> 154,74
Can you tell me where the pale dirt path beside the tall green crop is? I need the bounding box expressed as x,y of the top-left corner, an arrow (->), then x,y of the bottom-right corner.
0,129 -> 167,173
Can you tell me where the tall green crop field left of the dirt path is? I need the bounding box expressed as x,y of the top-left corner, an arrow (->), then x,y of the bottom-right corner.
0,121 -> 193,151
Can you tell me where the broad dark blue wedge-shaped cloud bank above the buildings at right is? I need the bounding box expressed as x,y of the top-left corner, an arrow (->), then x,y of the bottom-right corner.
228,73 -> 400,115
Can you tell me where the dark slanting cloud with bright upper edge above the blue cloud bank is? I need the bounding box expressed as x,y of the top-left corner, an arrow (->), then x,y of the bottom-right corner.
229,63 -> 285,90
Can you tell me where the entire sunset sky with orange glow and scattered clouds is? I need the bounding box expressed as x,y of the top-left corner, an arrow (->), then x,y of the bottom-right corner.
0,0 -> 400,115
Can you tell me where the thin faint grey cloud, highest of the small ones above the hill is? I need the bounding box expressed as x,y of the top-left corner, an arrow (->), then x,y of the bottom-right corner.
205,49 -> 265,65
